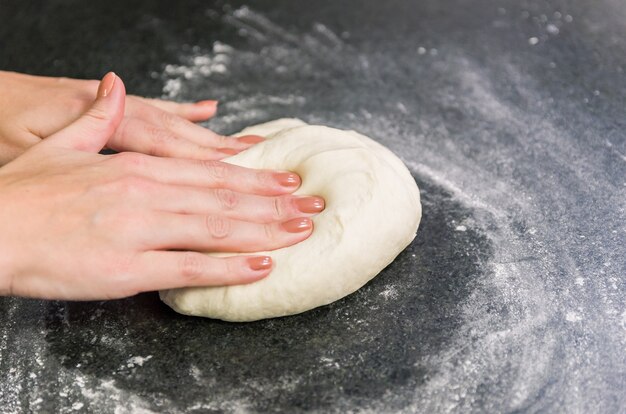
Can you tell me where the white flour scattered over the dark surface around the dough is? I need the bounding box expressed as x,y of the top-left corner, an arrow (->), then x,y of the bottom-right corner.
0,3 -> 626,413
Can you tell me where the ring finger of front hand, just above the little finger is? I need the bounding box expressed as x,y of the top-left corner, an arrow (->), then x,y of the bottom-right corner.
143,213 -> 313,253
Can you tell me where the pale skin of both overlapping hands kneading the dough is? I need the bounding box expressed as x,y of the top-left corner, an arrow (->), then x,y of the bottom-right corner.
0,72 -> 324,300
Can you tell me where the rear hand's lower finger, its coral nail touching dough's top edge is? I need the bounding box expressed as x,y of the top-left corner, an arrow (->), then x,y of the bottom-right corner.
136,106 -> 264,151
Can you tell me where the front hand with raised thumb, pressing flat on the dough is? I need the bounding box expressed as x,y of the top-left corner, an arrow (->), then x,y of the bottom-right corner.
0,73 -> 323,299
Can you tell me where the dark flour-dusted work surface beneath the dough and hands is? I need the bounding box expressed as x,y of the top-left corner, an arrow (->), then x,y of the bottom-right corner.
0,0 -> 626,413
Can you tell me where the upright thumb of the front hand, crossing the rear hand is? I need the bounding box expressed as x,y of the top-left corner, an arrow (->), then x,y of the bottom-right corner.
42,72 -> 126,152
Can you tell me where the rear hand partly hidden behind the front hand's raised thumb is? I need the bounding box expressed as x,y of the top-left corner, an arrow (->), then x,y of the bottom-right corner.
0,71 -> 263,165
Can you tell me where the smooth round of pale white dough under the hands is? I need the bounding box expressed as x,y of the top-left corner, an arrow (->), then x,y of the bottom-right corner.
160,119 -> 421,321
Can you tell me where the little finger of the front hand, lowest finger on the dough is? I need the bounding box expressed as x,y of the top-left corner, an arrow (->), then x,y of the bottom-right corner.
133,251 -> 272,292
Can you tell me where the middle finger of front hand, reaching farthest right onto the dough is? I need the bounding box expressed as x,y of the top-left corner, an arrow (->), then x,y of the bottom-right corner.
150,185 -> 324,223
